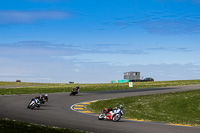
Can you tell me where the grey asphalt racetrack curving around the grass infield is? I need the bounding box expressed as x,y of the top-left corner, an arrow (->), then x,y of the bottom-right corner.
0,85 -> 200,133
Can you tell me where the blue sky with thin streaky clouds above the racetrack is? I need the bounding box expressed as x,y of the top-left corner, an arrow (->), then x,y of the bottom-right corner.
0,0 -> 200,83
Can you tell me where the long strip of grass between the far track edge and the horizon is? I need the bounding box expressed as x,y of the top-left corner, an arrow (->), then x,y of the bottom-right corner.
0,80 -> 200,95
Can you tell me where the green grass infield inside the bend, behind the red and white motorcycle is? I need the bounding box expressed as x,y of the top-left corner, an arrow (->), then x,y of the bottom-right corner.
87,90 -> 200,126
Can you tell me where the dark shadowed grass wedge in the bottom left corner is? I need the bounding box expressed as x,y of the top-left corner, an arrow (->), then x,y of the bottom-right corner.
0,119 -> 88,133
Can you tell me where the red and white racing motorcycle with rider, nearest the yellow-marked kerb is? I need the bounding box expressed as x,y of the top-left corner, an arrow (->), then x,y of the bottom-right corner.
98,107 -> 123,122
